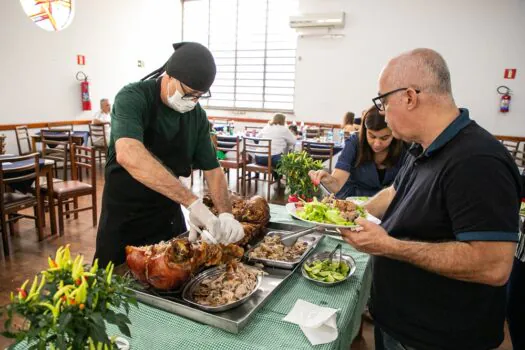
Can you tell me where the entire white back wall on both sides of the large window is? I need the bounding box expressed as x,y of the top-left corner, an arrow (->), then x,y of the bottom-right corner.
0,0 -> 525,152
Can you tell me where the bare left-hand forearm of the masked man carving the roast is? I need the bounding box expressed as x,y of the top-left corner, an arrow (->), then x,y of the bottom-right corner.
116,140 -> 198,207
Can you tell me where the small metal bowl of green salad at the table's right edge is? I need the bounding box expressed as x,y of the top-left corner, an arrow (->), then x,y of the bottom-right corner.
301,252 -> 357,287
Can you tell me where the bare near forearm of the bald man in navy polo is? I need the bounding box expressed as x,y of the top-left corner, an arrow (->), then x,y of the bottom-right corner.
385,239 -> 516,286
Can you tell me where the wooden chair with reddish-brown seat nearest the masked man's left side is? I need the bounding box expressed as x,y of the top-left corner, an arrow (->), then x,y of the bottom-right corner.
53,144 -> 97,235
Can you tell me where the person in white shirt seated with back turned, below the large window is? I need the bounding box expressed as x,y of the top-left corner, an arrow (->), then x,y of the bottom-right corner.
255,113 -> 296,177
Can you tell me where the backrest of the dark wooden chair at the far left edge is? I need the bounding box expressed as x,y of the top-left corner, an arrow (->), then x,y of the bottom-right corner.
0,153 -> 40,208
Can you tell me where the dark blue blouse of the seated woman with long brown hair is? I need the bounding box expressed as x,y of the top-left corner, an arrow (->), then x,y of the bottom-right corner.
335,134 -> 406,199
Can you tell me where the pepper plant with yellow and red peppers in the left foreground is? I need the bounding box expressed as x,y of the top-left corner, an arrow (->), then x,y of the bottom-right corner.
2,246 -> 137,350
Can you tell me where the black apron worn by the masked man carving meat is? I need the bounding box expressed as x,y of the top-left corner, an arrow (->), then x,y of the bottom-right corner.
95,79 -> 191,267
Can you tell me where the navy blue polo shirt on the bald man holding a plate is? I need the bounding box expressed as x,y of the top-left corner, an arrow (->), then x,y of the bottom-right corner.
370,109 -> 520,350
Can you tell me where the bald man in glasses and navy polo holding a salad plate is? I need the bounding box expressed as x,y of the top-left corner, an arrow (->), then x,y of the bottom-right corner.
342,49 -> 520,350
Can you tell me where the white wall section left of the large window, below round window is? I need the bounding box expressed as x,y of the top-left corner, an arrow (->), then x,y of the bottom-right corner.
0,0 -> 181,153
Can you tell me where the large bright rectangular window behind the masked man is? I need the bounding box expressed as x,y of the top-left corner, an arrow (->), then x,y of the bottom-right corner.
183,0 -> 298,111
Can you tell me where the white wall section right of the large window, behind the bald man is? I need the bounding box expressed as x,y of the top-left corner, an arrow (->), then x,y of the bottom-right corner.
295,0 -> 525,136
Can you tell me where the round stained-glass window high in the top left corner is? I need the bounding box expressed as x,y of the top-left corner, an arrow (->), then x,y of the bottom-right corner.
20,0 -> 73,32
